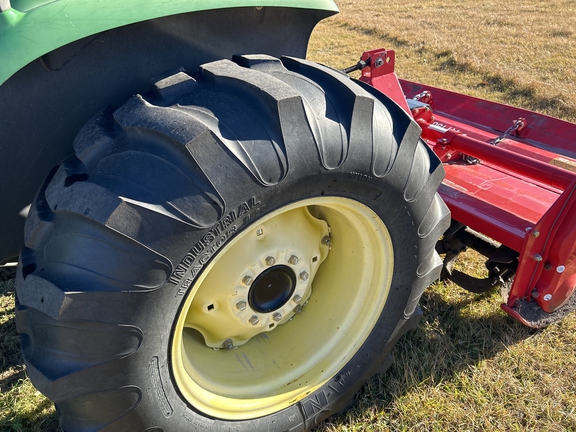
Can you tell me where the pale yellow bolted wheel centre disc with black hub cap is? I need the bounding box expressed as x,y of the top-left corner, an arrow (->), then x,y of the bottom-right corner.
180,207 -> 330,350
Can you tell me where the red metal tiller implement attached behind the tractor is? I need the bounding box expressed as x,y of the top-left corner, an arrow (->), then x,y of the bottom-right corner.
360,49 -> 576,327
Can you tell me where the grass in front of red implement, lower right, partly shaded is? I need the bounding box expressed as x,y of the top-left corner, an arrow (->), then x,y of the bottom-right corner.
316,272 -> 576,432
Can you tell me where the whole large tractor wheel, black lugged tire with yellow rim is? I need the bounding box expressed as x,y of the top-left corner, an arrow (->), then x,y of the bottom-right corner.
16,55 -> 449,432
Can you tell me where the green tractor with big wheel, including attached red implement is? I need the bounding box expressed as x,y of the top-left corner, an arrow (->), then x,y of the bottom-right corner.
0,0 -> 576,432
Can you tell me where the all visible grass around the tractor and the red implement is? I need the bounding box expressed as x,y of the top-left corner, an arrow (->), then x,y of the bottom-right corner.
0,0 -> 576,432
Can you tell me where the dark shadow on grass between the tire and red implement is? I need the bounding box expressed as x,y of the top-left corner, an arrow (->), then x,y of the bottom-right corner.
318,286 -> 541,431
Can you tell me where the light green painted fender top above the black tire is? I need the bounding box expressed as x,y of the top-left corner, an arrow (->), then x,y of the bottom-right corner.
0,0 -> 338,84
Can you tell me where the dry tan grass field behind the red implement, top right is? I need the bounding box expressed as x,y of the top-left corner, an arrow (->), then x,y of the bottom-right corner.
309,0 -> 576,121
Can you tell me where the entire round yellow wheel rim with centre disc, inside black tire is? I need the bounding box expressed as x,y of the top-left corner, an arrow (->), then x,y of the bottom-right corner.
171,197 -> 394,420
